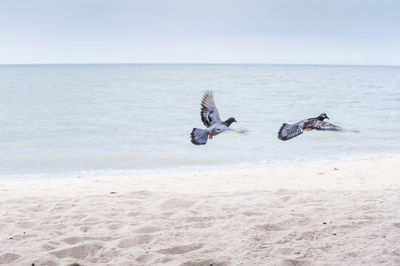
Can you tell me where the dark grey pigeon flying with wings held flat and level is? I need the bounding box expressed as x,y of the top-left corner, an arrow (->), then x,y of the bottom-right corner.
278,113 -> 343,140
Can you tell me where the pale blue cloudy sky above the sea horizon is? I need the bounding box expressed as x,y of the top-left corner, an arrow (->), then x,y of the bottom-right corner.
0,0 -> 400,65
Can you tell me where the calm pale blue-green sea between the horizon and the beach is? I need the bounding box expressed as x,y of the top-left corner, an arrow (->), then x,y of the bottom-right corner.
0,64 -> 400,176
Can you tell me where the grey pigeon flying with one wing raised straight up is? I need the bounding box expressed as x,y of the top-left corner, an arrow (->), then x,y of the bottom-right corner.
190,91 -> 245,145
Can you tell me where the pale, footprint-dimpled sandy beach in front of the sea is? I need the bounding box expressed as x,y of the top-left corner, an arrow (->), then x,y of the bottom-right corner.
0,157 -> 400,266
